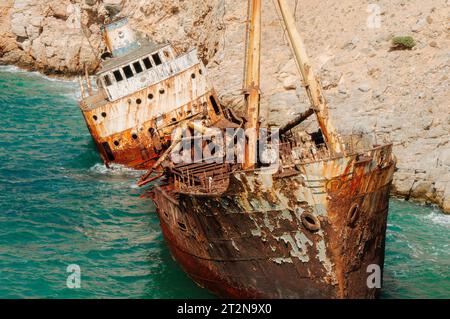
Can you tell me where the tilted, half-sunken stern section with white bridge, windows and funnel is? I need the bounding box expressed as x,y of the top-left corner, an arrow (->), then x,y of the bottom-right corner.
80,19 -> 222,169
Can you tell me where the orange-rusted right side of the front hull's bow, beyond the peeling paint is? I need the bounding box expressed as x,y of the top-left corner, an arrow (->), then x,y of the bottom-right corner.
323,145 -> 395,298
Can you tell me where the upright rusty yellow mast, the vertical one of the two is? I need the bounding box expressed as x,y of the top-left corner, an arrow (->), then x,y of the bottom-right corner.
244,0 -> 261,169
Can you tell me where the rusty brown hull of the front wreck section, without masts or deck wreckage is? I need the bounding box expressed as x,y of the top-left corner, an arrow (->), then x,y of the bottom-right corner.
150,145 -> 395,298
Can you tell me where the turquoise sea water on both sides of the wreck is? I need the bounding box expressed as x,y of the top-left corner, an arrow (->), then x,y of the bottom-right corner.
0,67 -> 450,298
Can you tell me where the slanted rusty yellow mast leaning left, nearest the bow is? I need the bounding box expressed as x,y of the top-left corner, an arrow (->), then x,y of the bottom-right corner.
277,0 -> 343,154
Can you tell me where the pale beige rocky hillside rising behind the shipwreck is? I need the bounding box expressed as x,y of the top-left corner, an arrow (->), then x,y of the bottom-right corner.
0,0 -> 450,215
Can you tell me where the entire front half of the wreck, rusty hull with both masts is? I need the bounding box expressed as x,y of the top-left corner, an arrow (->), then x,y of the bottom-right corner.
141,0 -> 396,298
